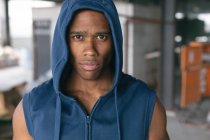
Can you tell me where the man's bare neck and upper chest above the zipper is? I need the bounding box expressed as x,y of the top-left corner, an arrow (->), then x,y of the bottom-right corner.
65,71 -> 114,113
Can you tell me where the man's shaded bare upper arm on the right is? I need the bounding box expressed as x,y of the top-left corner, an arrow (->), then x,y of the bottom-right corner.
149,98 -> 169,140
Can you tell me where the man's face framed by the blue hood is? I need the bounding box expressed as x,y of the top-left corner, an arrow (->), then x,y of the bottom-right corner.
68,10 -> 113,80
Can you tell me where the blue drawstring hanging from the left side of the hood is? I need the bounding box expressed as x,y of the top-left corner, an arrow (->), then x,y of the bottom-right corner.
54,94 -> 61,140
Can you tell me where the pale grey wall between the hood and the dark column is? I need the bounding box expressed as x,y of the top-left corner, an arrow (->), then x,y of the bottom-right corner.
116,2 -> 160,82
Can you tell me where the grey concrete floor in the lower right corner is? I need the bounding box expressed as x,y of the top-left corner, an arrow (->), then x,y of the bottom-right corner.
167,111 -> 210,140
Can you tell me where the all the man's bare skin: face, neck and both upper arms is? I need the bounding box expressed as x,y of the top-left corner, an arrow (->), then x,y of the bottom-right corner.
13,10 -> 169,140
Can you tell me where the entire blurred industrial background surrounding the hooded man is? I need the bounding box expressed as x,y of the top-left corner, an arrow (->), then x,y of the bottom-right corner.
0,0 -> 210,140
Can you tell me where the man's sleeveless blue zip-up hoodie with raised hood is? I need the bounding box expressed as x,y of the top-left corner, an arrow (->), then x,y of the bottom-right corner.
23,0 -> 156,140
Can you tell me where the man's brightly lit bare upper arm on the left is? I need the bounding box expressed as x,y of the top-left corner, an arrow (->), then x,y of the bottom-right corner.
12,101 -> 32,140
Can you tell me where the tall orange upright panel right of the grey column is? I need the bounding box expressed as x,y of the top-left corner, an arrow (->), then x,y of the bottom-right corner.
181,44 -> 202,108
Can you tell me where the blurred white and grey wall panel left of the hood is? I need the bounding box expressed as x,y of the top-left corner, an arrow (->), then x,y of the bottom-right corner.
32,6 -> 60,79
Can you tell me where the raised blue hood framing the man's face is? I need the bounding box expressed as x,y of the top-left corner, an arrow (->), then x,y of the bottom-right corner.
51,0 -> 123,93
